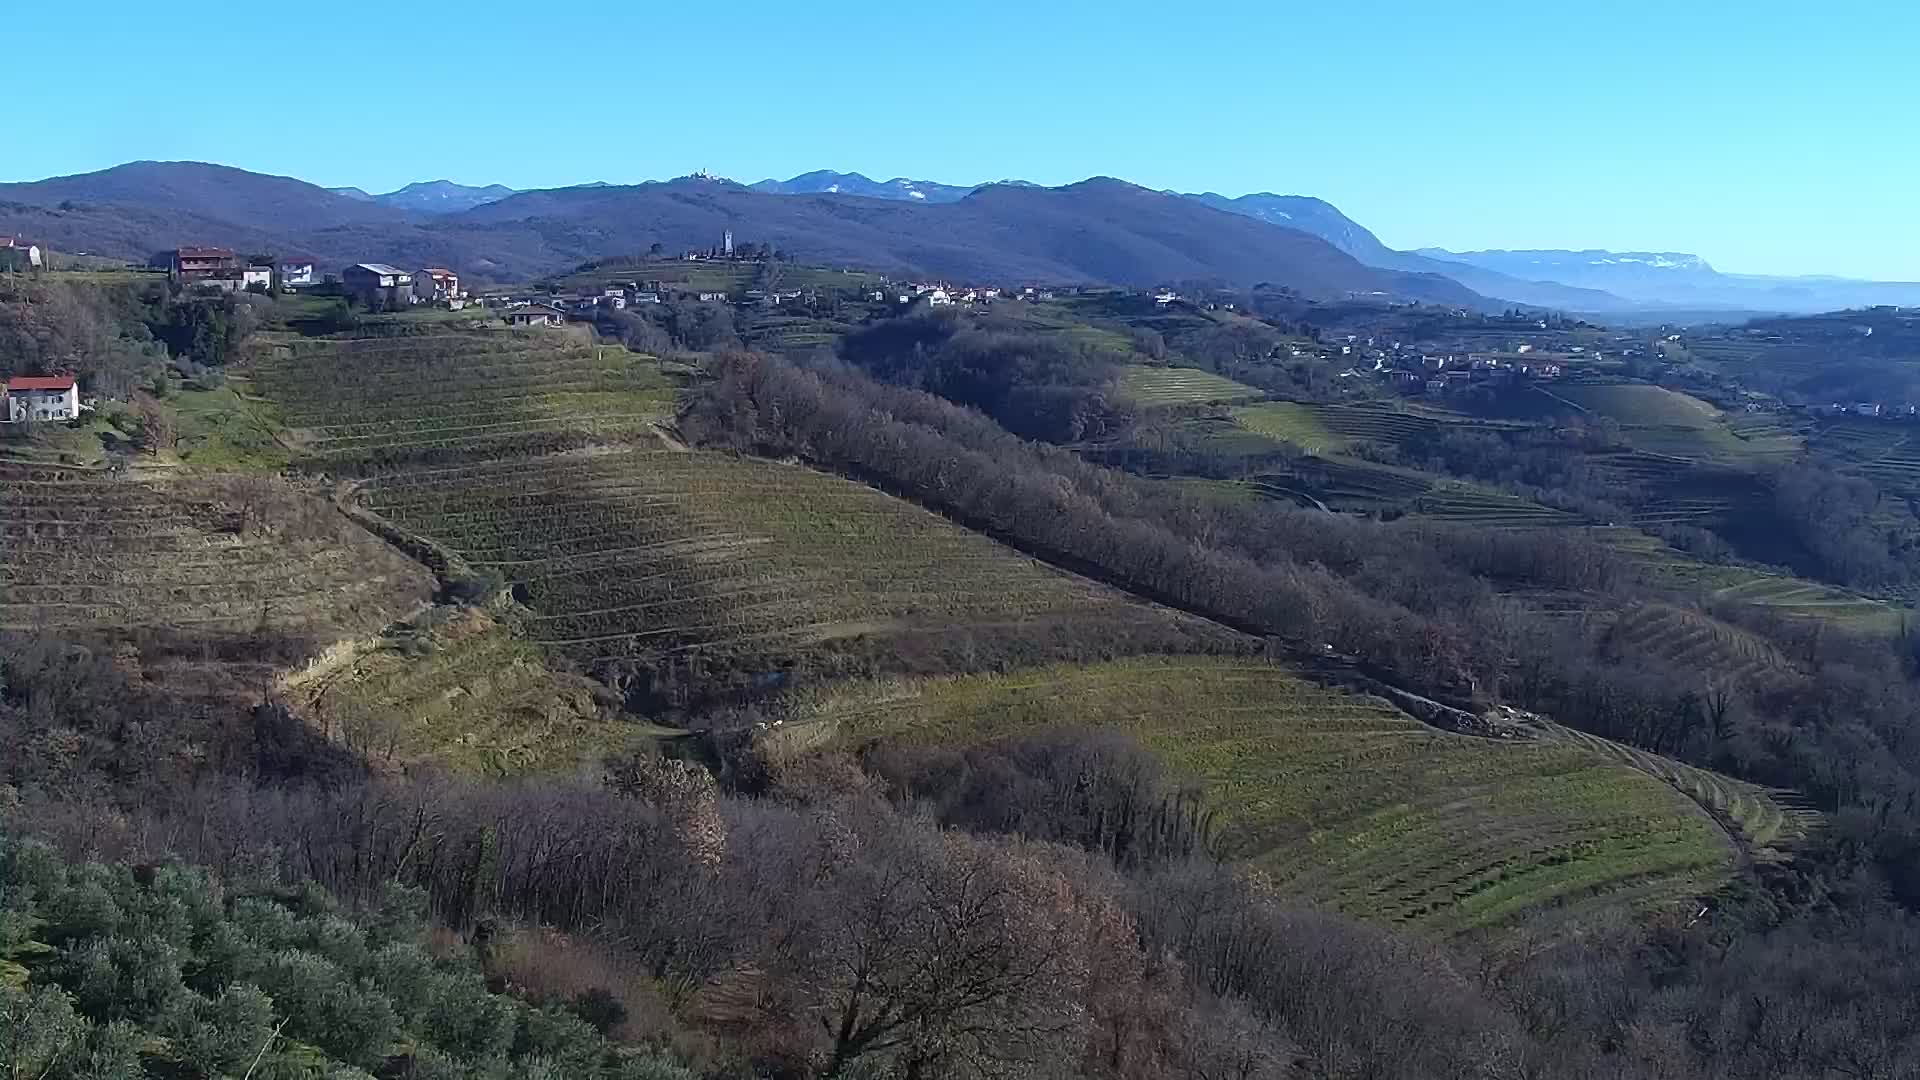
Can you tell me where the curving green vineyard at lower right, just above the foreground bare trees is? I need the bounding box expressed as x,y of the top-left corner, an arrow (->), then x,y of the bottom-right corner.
776,659 -> 1736,934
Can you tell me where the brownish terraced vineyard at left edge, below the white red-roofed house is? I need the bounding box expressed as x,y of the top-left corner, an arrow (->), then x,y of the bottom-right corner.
0,463 -> 432,636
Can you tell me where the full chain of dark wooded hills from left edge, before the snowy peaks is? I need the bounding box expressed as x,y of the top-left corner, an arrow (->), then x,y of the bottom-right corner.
0,161 -> 1494,299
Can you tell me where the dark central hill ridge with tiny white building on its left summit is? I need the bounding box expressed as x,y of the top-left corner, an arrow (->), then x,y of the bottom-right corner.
445,179 -> 1486,297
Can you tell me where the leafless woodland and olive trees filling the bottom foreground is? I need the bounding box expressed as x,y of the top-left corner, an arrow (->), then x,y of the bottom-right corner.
11,630 -> 1920,1078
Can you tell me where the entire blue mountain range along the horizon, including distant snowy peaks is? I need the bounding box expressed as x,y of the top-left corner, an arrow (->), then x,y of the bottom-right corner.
0,161 -> 1920,317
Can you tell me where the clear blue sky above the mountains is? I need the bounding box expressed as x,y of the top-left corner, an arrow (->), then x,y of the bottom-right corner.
0,0 -> 1920,281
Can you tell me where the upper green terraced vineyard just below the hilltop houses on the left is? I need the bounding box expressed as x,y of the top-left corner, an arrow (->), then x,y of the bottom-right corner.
250,331 -> 678,467
